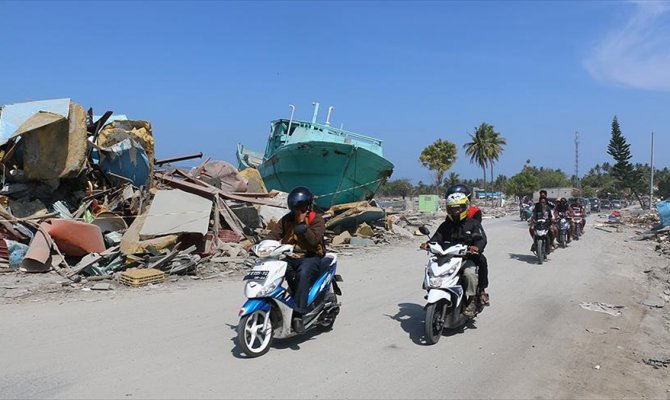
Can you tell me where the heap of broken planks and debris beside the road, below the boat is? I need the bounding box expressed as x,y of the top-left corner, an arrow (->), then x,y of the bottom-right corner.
0,99 -> 413,296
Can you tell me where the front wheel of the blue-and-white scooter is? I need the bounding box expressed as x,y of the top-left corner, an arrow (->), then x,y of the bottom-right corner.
237,311 -> 274,358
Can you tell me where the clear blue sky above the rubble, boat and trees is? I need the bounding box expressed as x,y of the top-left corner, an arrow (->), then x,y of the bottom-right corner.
0,1 -> 670,182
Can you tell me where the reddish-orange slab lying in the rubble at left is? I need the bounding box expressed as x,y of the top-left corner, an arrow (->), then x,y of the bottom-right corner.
41,219 -> 105,257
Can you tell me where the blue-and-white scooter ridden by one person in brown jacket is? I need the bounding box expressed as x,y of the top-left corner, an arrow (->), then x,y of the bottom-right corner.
237,240 -> 342,357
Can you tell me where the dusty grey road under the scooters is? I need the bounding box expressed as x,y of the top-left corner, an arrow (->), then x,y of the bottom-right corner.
0,217 -> 652,398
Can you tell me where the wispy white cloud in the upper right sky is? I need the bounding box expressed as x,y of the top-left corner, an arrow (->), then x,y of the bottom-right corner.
585,1 -> 670,91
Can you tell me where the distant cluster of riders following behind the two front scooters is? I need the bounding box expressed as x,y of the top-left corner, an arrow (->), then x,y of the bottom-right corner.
521,190 -> 586,252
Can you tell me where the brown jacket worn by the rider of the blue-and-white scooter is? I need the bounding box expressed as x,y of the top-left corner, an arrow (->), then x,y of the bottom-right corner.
267,213 -> 326,257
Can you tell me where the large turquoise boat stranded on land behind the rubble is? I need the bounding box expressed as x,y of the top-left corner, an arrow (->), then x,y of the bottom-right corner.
237,103 -> 393,209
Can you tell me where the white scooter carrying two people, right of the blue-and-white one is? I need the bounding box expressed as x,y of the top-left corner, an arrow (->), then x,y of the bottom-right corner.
419,226 -> 482,345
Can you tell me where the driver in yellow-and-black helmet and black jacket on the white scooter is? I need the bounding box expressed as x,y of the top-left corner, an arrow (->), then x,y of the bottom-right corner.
419,192 -> 486,318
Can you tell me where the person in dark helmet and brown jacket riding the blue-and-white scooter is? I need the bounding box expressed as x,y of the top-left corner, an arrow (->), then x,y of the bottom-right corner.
267,186 -> 326,333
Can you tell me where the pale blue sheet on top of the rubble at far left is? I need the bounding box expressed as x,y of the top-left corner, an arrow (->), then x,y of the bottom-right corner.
0,99 -> 70,145
